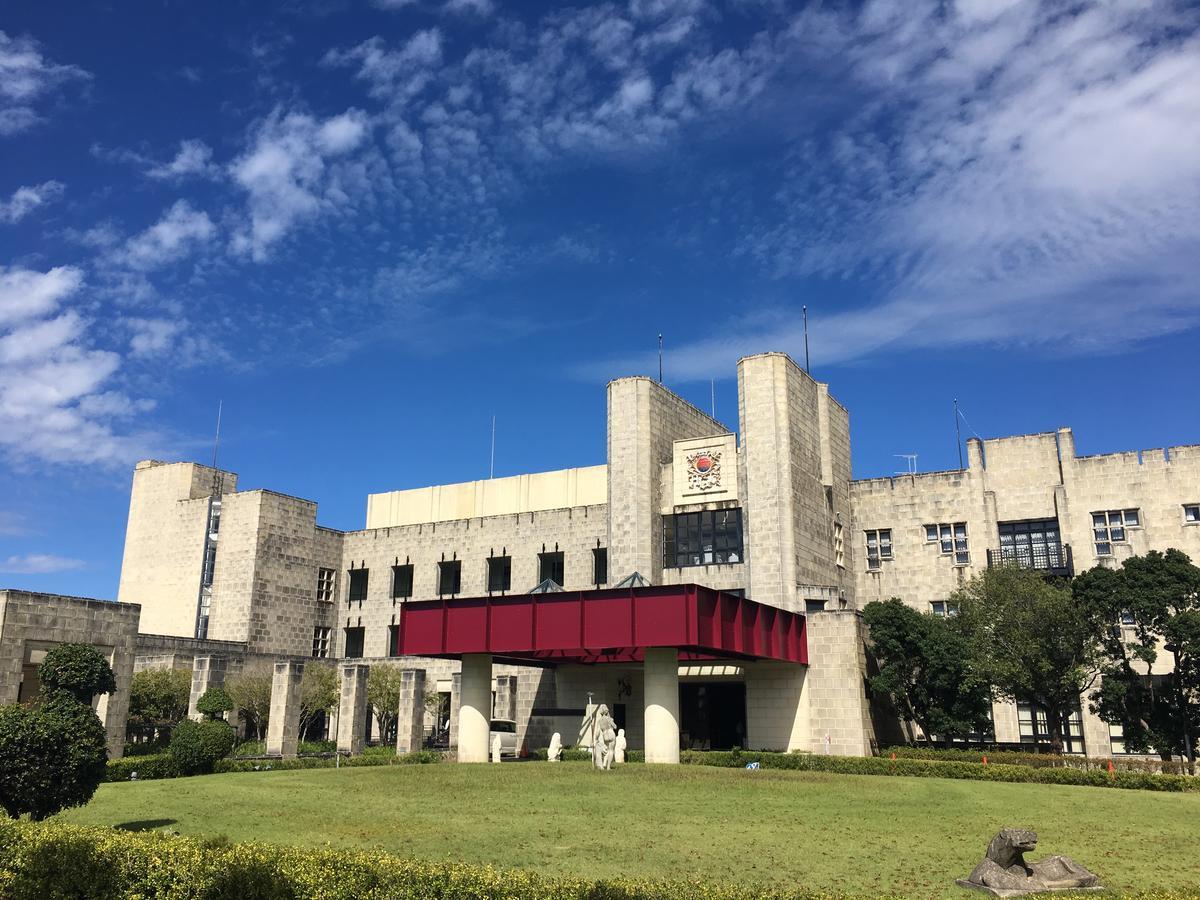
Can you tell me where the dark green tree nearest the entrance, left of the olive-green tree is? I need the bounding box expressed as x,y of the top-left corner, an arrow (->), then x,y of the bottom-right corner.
863,598 -> 991,742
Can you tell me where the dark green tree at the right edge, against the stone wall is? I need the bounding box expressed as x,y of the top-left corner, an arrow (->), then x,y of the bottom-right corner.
1074,550 -> 1200,773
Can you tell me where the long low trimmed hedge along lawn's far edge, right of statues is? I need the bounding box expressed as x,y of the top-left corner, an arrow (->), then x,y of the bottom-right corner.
679,750 -> 1200,792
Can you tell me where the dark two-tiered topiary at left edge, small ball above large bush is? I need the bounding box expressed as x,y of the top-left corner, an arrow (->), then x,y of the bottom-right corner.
0,644 -> 115,821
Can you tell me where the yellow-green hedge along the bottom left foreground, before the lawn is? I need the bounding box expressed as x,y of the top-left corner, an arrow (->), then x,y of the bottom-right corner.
0,821 -> 825,900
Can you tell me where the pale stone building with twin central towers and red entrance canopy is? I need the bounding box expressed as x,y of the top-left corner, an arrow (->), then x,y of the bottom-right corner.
110,353 -> 1200,761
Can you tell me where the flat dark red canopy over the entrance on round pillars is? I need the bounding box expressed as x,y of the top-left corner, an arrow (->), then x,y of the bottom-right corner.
395,584 -> 809,664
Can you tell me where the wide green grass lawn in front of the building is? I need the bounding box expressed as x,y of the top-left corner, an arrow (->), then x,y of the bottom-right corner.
62,762 -> 1200,896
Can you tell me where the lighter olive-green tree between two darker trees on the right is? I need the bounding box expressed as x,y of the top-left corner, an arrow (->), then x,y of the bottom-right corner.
950,565 -> 1104,754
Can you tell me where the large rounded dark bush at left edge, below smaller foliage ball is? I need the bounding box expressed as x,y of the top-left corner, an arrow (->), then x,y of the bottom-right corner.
0,691 -> 108,820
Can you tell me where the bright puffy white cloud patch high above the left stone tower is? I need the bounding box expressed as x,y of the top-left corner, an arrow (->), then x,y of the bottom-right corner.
229,109 -> 368,260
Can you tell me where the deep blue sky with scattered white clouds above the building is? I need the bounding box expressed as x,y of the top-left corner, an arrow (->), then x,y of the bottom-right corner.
0,0 -> 1200,598
